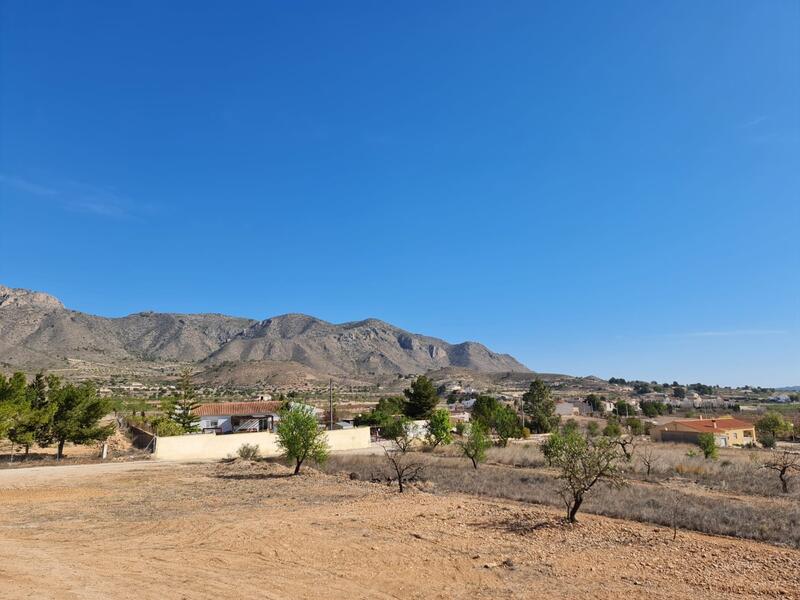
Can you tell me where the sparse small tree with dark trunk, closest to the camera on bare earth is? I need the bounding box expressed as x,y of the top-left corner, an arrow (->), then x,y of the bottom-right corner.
548,432 -> 624,523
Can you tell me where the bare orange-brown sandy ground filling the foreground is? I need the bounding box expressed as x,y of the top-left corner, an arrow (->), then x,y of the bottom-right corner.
0,461 -> 800,600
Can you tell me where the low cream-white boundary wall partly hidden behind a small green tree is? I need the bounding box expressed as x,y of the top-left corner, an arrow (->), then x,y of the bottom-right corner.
153,427 -> 370,460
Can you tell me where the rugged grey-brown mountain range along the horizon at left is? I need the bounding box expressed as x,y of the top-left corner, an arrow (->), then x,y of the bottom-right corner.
0,286 -> 530,383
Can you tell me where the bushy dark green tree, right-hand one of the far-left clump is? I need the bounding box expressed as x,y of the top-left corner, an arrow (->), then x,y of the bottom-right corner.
48,383 -> 114,460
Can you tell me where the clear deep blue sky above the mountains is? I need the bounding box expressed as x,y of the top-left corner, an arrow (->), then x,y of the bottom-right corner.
0,0 -> 800,386
